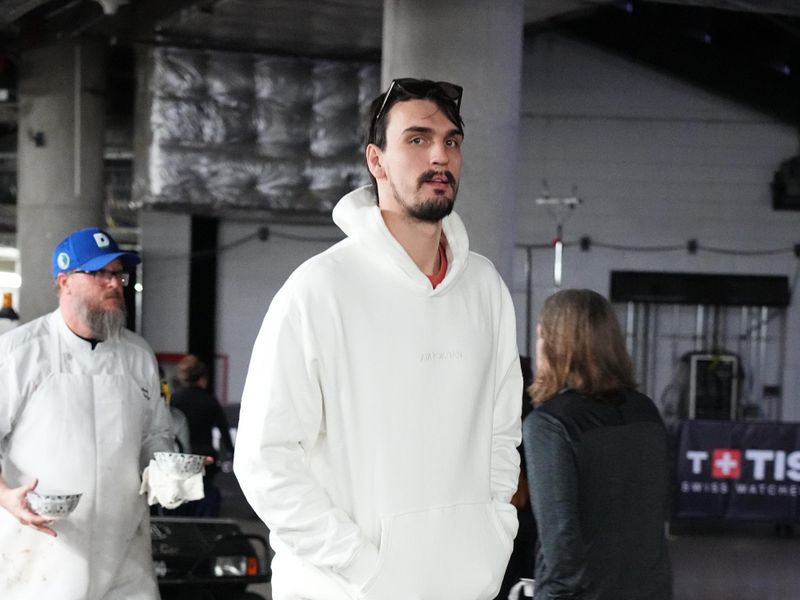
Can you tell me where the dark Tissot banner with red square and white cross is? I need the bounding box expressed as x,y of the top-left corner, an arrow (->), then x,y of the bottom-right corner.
675,421 -> 800,521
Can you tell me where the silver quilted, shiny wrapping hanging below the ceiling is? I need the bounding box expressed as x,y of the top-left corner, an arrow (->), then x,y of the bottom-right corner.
139,47 -> 380,213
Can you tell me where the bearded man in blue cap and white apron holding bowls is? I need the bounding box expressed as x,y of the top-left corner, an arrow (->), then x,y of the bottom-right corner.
0,228 -> 172,600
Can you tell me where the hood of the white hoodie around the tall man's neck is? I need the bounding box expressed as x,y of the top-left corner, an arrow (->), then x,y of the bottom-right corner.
332,185 -> 469,295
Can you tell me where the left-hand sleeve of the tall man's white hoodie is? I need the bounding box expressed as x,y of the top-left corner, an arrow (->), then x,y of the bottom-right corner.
234,288 -> 378,585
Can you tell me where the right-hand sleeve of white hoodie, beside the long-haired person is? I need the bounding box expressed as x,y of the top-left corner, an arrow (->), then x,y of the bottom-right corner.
491,284 -> 522,539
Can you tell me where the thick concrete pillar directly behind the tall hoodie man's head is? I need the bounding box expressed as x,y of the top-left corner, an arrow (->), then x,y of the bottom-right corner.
382,0 -> 523,282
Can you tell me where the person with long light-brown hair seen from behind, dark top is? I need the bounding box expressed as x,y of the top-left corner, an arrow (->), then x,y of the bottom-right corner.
523,290 -> 672,600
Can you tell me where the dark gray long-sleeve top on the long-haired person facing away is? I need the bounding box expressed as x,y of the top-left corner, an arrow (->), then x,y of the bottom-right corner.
523,390 -> 672,600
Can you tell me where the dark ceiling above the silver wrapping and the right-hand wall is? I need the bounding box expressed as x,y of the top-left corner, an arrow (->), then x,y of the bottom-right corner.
0,0 -> 800,123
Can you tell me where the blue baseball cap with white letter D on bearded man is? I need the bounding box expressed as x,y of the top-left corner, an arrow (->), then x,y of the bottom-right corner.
53,227 -> 142,278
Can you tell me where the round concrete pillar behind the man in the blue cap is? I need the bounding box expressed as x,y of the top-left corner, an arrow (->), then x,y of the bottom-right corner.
17,41 -> 106,321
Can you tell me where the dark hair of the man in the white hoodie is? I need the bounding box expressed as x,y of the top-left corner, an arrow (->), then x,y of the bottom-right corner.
364,79 -> 464,200
